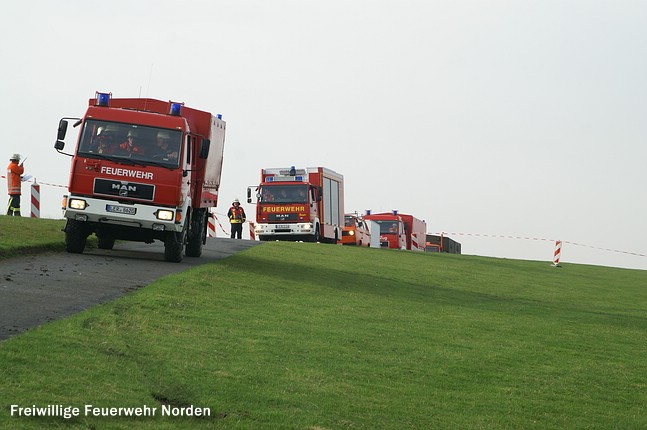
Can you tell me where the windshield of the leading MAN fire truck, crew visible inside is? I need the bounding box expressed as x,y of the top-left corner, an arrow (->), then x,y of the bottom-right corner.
77,120 -> 182,168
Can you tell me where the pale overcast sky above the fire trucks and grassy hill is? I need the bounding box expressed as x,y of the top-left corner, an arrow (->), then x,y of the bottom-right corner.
0,0 -> 647,269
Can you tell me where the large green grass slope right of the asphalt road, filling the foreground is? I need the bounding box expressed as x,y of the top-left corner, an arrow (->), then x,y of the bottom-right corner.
0,217 -> 647,430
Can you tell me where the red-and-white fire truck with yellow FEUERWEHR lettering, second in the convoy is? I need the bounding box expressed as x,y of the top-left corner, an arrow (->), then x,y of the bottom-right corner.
247,166 -> 344,243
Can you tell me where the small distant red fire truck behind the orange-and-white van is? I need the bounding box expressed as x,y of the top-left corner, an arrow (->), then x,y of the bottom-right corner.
364,211 -> 427,251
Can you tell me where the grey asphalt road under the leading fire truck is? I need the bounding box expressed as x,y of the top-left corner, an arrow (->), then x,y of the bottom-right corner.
0,238 -> 260,341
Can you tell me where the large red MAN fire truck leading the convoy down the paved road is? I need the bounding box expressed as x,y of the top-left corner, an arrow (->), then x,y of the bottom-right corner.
54,93 -> 225,262
